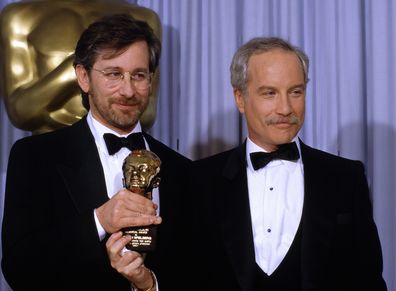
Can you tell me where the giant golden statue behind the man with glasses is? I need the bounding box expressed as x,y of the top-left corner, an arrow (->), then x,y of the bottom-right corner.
0,0 -> 161,134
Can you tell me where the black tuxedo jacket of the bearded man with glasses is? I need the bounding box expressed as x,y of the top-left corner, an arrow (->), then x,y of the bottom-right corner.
2,118 -> 190,291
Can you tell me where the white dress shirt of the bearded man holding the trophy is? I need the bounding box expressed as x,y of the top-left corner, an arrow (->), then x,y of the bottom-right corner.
87,111 -> 160,240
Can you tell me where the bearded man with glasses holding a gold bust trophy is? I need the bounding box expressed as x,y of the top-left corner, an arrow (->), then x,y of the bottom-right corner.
2,14 -> 190,291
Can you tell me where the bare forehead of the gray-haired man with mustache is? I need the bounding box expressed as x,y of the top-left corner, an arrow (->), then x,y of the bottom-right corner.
248,49 -> 304,82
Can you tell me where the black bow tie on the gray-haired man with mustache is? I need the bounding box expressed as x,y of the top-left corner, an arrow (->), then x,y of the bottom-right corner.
250,142 -> 300,170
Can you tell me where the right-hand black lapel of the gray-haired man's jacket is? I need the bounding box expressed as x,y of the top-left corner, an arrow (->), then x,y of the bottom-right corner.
300,141 -> 335,290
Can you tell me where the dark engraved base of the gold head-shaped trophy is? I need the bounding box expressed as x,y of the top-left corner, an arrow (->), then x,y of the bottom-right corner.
122,225 -> 157,252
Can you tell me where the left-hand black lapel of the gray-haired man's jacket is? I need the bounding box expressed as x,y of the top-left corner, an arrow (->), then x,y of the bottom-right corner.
218,143 -> 255,291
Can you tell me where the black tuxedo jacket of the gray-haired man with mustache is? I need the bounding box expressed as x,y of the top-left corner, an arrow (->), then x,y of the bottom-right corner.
191,142 -> 386,291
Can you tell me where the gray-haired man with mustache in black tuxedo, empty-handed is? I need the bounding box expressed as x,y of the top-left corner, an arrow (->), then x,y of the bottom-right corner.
191,38 -> 386,291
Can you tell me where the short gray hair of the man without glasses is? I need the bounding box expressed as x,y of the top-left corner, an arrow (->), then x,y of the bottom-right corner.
230,37 -> 309,95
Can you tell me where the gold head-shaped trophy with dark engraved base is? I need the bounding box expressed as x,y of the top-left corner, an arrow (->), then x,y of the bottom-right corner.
122,150 -> 161,252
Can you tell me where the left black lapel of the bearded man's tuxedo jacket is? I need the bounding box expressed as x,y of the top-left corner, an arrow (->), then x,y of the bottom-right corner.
57,118 -> 108,213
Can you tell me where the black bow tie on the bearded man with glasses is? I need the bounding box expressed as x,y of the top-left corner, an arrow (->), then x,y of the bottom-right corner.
103,132 -> 146,155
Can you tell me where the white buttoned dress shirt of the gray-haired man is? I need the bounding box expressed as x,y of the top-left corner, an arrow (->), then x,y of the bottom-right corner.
246,138 -> 304,275
